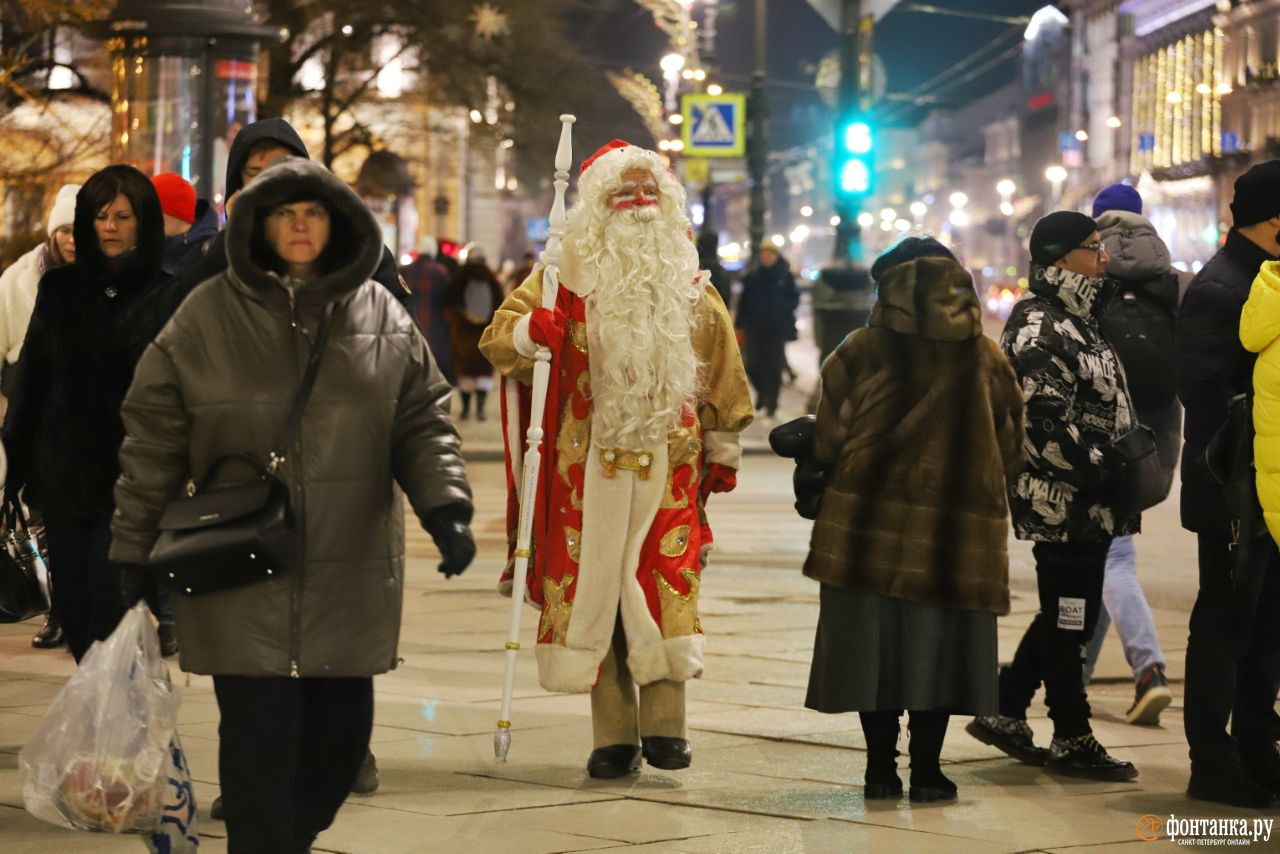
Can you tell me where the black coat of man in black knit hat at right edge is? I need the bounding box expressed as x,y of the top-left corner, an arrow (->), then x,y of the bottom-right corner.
1175,229 -> 1275,536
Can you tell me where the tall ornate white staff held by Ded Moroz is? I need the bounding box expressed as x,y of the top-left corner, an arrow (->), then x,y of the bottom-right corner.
493,113 -> 577,762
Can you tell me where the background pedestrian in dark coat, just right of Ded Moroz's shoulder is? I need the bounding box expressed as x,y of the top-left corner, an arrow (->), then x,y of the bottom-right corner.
735,241 -> 800,420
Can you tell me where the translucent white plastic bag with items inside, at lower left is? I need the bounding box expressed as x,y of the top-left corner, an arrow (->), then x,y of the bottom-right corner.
18,602 -> 196,851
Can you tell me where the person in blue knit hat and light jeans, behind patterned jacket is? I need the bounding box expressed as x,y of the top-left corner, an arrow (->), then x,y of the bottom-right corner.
1084,184 -> 1183,725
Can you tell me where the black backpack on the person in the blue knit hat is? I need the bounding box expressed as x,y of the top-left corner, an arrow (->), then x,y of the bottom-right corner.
1098,271 -> 1178,410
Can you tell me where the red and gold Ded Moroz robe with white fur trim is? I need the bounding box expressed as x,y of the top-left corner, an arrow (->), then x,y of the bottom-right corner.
480,269 -> 751,693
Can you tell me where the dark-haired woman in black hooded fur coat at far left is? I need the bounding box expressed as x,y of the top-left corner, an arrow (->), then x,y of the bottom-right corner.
4,165 -> 173,662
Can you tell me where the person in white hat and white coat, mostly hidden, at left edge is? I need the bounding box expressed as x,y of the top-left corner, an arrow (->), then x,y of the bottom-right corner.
0,184 -> 81,649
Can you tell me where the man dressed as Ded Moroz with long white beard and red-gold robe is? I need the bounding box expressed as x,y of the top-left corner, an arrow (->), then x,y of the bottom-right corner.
480,140 -> 751,777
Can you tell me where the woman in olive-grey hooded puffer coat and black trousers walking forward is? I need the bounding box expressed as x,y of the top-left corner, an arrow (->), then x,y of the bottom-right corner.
111,159 -> 475,853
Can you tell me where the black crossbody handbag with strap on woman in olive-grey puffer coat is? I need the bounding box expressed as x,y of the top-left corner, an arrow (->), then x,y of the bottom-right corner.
148,306 -> 332,595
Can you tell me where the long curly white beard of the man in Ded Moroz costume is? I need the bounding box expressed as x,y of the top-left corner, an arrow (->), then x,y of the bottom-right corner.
570,206 -> 701,451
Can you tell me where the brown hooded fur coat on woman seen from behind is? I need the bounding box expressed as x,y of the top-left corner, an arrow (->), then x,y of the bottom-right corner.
804,257 -> 1023,613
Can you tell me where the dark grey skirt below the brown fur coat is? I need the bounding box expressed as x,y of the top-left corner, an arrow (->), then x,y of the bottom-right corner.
804,584 -> 997,714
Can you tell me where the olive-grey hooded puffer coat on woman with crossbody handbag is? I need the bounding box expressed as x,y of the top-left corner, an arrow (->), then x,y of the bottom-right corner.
110,159 -> 471,676
